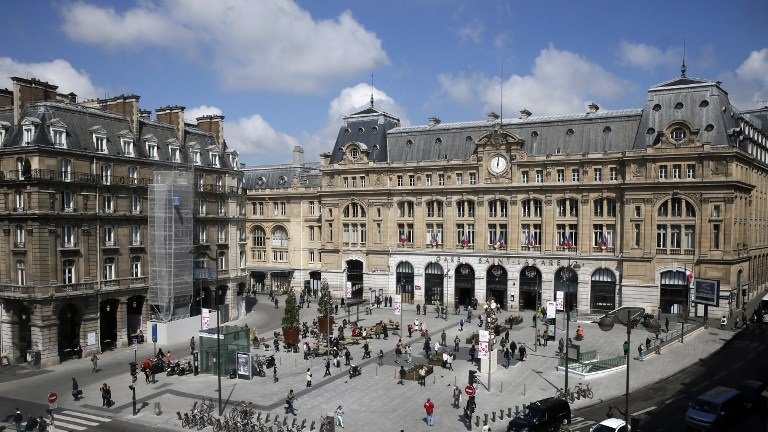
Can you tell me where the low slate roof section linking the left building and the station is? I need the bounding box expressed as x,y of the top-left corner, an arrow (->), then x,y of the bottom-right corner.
242,162 -> 322,190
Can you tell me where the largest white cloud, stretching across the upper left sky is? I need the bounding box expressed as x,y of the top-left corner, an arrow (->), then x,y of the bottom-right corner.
58,0 -> 388,93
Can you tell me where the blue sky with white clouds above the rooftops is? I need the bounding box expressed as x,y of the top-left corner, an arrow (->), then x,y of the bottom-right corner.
0,0 -> 768,165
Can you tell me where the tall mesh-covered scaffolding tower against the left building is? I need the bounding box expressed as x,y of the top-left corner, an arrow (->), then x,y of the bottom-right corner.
149,171 -> 194,322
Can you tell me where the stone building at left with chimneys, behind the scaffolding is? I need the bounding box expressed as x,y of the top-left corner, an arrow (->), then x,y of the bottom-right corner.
0,77 -> 245,365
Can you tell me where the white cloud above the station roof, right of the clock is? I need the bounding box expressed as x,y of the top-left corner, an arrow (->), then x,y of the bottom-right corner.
438,45 -> 631,117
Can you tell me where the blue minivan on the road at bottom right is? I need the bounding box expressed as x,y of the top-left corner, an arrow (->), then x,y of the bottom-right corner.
685,386 -> 744,430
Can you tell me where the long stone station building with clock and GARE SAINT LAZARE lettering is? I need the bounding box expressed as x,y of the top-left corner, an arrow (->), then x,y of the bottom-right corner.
246,73 -> 768,316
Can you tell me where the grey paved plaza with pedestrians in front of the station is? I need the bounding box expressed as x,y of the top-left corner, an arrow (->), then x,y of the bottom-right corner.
0,301 -> 732,432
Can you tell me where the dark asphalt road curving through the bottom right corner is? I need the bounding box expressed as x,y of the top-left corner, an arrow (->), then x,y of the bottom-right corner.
572,326 -> 768,432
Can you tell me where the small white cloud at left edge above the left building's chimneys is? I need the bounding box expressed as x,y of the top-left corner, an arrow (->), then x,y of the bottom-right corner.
0,57 -> 105,99
